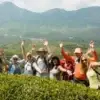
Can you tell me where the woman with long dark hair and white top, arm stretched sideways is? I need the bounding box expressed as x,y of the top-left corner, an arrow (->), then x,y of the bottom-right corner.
50,56 -> 67,80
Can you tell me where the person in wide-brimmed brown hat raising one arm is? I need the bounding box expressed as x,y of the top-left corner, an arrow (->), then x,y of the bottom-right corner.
36,40 -> 52,78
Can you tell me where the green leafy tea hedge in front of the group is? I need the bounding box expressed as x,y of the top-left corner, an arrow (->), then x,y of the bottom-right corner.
0,75 -> 100,100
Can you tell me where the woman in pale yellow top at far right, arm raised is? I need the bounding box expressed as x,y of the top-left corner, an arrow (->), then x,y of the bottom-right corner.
86,41 -> 100,89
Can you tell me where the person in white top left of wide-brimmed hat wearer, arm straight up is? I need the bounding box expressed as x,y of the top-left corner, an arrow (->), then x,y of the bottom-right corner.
21,41 -> 42,75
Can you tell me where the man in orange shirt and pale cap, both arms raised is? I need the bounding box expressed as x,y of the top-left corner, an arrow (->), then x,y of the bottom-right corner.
60,41 -> 98,86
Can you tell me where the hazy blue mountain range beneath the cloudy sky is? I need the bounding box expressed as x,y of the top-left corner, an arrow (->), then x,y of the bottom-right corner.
0,2 -> 100,27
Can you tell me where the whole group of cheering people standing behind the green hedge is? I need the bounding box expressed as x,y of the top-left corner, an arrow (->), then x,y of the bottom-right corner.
0,41 -> 100,89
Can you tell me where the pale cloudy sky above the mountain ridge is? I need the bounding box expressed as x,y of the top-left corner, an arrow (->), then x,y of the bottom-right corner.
0,0 -> 100,12
